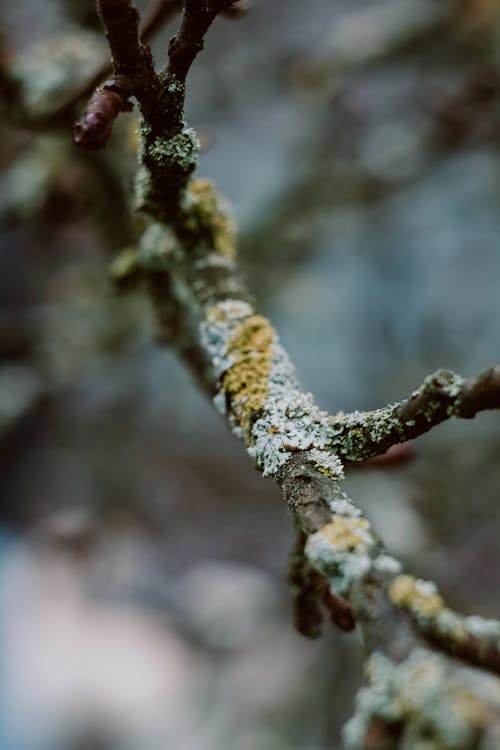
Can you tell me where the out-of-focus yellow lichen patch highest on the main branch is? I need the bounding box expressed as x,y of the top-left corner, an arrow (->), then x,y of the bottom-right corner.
184,179 -> 236,258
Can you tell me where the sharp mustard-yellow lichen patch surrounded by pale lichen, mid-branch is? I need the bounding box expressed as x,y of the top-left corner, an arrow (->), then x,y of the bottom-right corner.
222,315 -> 276,425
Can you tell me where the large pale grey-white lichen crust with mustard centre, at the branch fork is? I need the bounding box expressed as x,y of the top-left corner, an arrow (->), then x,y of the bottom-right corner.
201,299 -> 343,479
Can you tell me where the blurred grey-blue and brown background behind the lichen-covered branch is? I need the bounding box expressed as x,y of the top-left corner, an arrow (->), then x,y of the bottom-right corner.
0,0 -> 500,750
